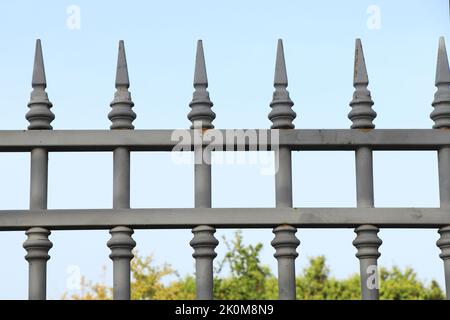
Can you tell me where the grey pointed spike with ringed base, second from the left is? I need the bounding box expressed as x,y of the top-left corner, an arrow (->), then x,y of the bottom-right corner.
108,40 -> 136,129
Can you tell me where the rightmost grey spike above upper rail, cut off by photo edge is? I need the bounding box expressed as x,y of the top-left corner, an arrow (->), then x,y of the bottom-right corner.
430,37 -> 450,129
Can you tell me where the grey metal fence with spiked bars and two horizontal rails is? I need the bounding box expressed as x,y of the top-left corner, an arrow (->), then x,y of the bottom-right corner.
0,38 -> 450,299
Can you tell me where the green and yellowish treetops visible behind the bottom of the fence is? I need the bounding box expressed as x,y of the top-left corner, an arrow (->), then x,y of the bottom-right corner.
63,232 -> 444,300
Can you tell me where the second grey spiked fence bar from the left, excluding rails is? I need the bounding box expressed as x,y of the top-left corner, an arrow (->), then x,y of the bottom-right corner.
107,41 -> 136,300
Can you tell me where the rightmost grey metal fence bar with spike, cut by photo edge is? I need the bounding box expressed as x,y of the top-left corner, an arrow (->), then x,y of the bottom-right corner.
430,37 -> 450,300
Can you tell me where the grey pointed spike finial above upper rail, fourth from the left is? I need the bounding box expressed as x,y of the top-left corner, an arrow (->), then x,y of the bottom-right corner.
269,39 -> 297,129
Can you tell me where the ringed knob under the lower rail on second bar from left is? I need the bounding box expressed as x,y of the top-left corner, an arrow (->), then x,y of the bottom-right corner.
107,227 -> 136,261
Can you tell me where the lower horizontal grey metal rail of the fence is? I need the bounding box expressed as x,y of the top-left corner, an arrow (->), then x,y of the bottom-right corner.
0,208 -> 450,231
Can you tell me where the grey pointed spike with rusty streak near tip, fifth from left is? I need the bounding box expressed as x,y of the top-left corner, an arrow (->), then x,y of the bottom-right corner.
348,39 -> 377,129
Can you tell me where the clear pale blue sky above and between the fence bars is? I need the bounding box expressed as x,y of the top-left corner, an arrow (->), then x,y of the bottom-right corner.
0,0 -> 450,299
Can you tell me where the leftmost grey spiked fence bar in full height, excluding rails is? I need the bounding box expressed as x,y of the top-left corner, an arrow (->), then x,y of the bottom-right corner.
23,39 -> 55,300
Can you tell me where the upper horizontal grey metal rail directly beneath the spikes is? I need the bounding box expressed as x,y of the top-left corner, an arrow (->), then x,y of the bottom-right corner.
0,129 -> 450,152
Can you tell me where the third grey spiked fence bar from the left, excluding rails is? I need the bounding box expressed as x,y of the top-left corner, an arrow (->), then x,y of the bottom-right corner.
188,40 -> 219,300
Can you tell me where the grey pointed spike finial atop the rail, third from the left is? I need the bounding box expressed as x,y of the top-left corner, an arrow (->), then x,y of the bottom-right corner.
188,40 -> 216,129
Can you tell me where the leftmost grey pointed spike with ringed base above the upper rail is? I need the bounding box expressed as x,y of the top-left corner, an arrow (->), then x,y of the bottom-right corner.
25,39 -> 55,130
